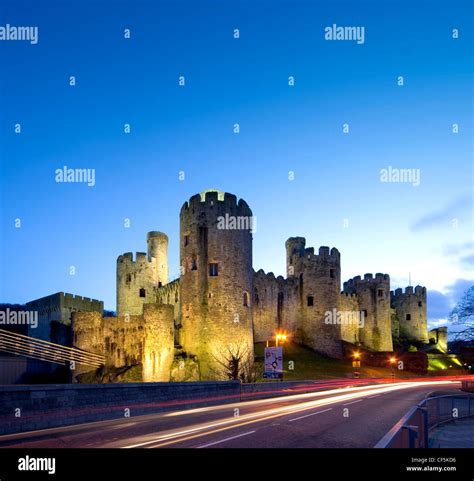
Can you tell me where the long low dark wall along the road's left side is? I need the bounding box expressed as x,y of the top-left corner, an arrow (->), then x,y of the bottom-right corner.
0,381 -> 240,434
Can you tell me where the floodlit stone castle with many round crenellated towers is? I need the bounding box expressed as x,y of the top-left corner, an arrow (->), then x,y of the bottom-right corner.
73,190 -> 429,381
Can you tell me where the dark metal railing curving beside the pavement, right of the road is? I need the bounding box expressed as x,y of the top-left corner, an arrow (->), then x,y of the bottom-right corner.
374,394 -> 474,448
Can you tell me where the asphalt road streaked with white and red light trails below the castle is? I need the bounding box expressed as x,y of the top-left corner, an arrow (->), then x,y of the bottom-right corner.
0,381 -> 460,448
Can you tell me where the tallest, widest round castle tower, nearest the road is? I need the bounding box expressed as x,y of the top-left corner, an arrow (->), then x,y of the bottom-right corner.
180,191 -> 253,380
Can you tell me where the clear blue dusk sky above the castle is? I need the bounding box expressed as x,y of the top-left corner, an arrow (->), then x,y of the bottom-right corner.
0,0 -> 474,326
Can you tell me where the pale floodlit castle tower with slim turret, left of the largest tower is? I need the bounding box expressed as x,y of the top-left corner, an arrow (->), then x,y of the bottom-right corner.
117,231 -> 168,316
